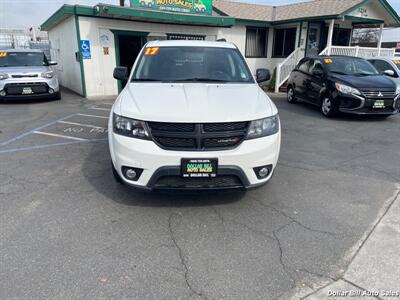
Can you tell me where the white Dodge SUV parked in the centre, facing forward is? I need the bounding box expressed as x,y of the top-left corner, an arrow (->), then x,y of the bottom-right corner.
109,41 -> 281,190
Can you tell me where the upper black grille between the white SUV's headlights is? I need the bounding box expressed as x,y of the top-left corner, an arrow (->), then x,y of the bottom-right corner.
148,122 -> 249,151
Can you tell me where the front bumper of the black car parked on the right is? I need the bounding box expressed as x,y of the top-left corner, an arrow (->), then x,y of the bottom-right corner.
333,93 -> 400,115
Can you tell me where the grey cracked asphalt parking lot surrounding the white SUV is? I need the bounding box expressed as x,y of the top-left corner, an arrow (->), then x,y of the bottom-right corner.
0,92 -> 400,299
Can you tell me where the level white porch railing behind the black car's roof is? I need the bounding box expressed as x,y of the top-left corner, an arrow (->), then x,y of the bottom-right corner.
319,46 -> 396,58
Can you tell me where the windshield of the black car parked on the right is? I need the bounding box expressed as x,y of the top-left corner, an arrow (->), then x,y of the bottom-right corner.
322,57 -> 379,76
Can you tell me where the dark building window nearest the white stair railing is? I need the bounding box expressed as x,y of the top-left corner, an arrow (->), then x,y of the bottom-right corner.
272,28 -> 297,57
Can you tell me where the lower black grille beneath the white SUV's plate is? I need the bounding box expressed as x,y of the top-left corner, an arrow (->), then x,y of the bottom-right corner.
154,175 -> 243,189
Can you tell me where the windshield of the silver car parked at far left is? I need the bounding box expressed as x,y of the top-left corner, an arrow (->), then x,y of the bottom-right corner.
0,51 -> 48,67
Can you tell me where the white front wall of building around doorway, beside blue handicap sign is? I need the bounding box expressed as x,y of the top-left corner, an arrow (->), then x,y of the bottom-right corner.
79,17 -> 217,98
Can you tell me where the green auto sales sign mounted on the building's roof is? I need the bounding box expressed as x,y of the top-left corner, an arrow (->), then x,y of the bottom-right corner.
131,0 -> 212,15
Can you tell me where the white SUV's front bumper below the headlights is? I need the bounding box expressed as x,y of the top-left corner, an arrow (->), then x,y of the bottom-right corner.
109,130 -> 281,190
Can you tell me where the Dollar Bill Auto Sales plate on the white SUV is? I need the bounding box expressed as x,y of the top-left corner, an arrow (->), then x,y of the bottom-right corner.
181,158 -> 218,178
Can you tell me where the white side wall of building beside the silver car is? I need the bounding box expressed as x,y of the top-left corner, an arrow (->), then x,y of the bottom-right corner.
49,16 -> 82,94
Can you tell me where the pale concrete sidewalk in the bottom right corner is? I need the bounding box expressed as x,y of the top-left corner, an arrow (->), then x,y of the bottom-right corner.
299,185 -> 400,300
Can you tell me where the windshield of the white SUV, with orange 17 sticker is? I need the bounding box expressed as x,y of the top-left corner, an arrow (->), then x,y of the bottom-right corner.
132,47 -> 254,83
